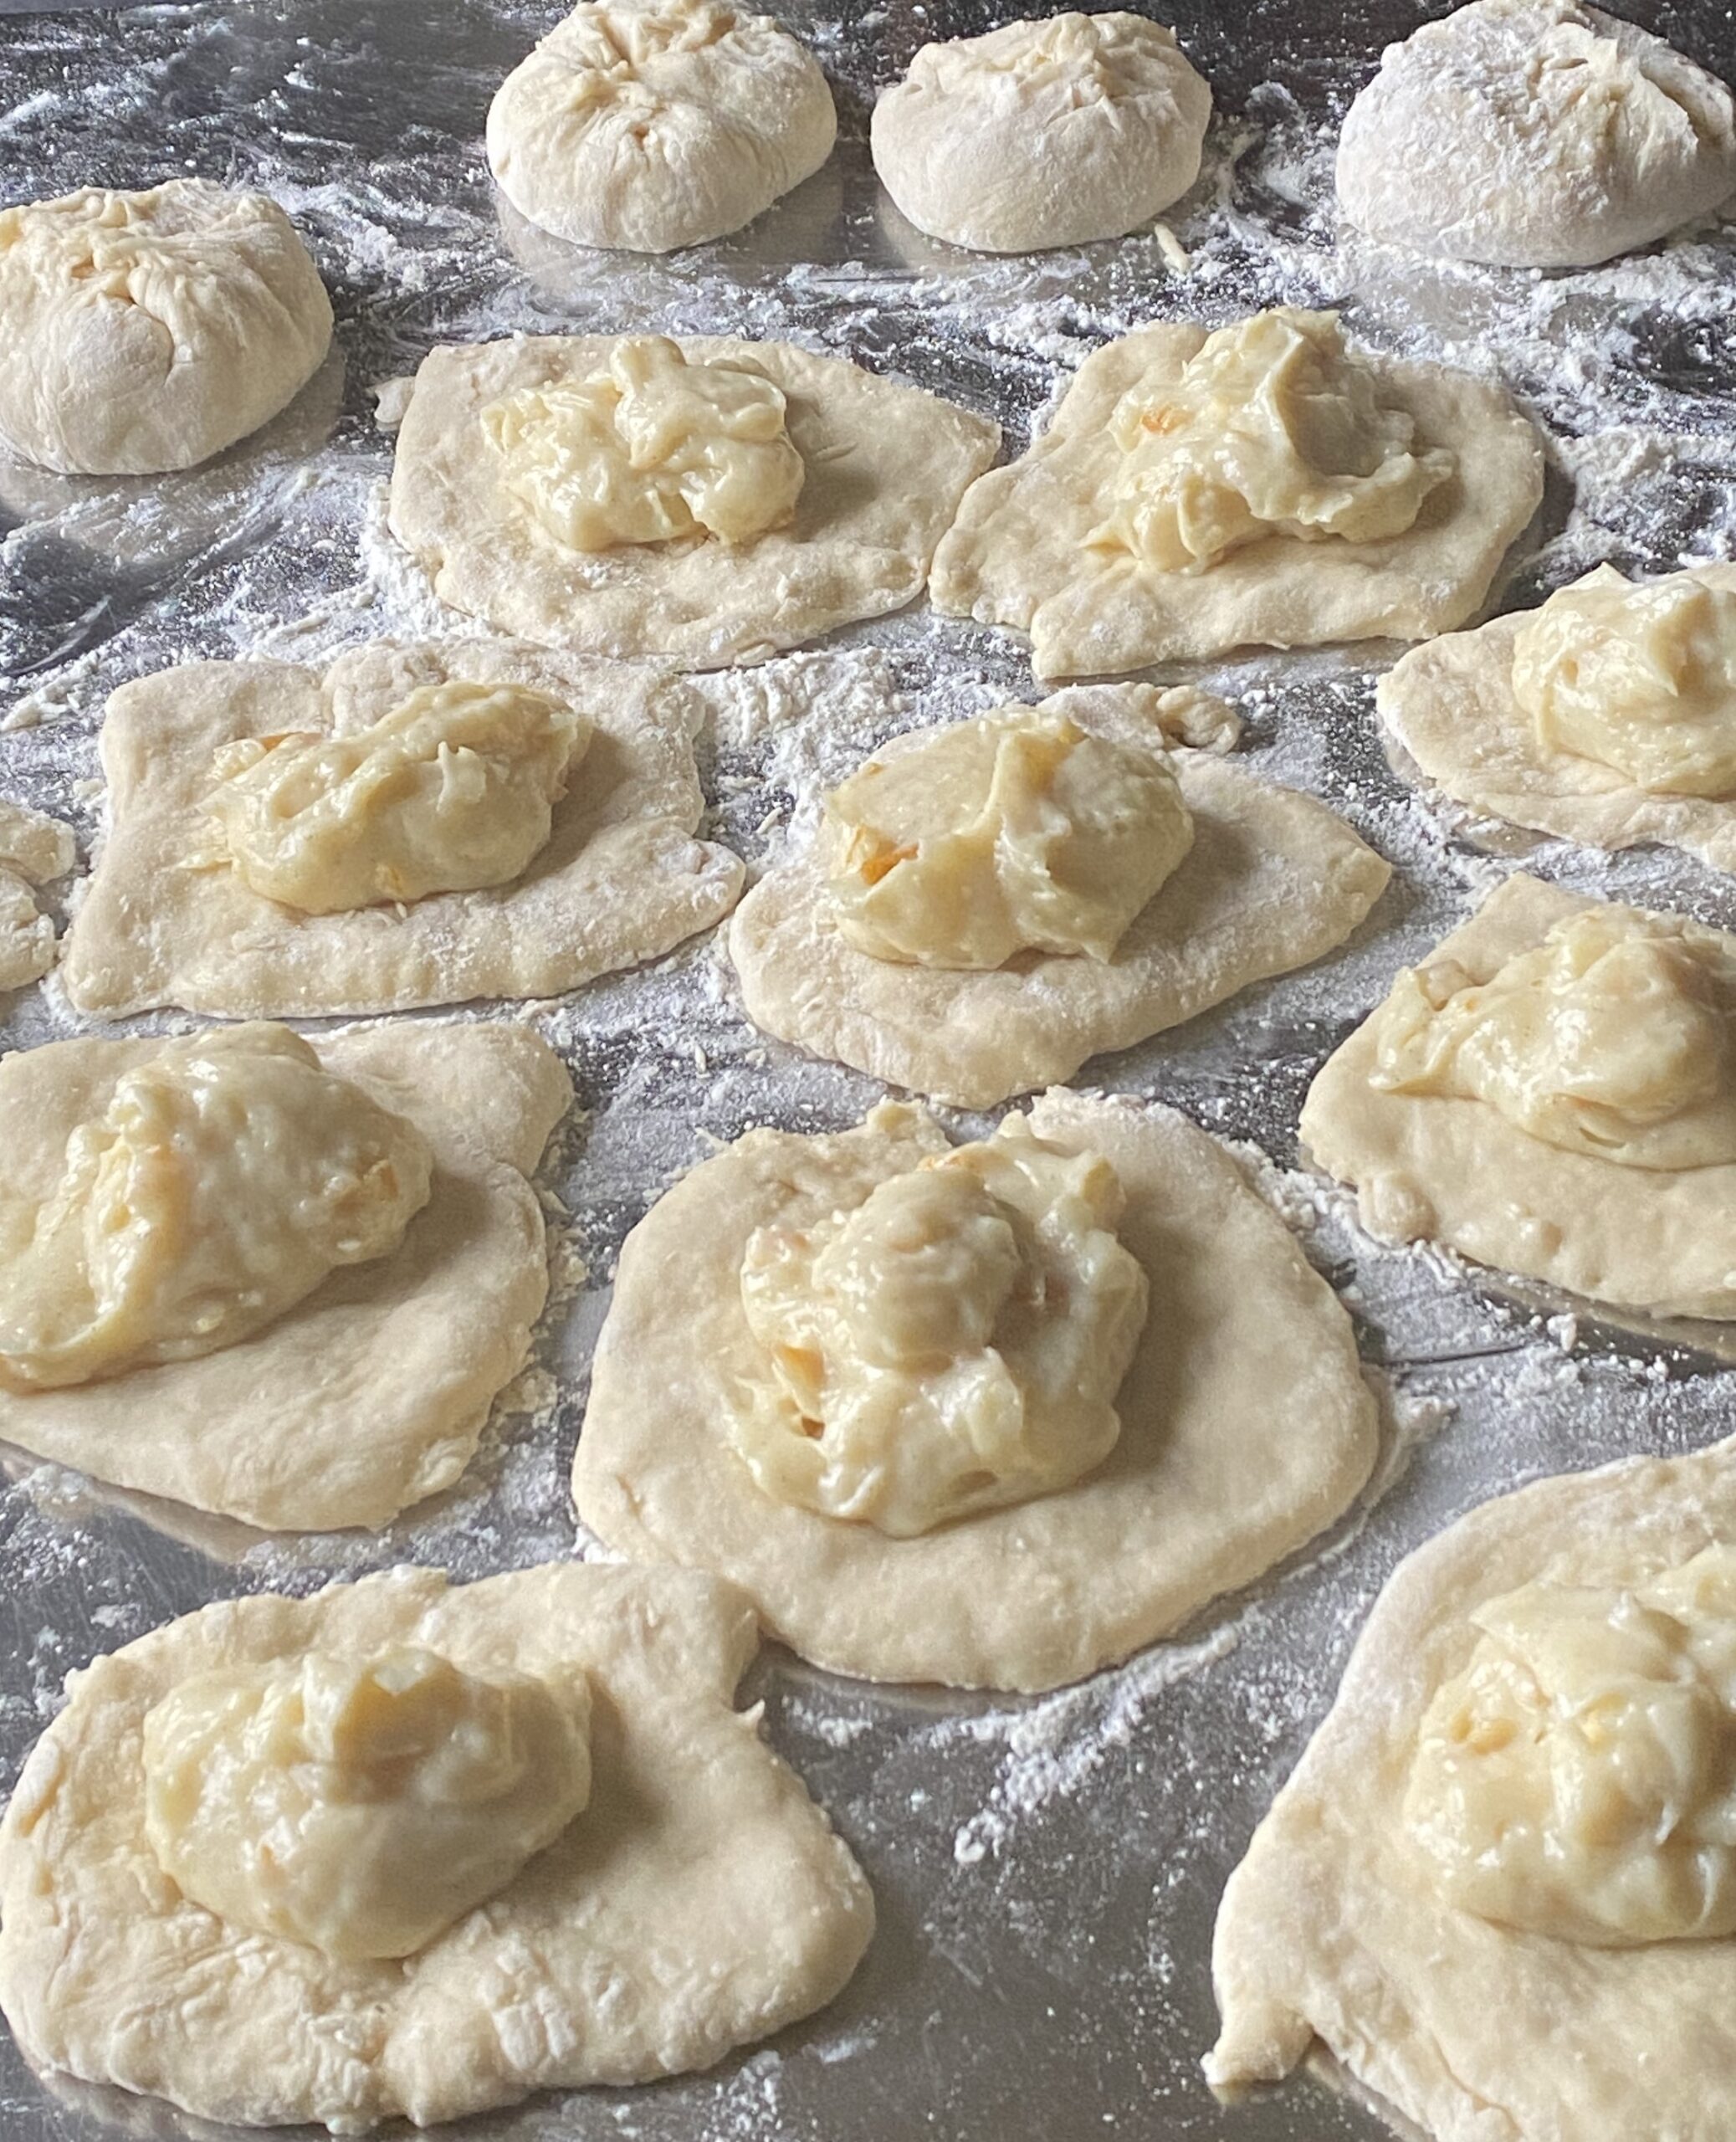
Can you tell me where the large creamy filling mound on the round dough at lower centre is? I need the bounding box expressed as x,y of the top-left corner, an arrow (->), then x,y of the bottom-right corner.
728,1116 -> 1147,1538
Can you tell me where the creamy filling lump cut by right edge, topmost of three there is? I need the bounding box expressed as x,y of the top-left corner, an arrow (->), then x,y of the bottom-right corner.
1513,566 -> 1736,797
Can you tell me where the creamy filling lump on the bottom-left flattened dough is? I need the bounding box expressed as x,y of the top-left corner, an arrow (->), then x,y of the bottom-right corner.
143,1645 -> 591,1962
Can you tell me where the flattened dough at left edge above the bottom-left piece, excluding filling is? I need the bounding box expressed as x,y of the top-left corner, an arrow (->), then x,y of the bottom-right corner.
0,1022 -> 571,1531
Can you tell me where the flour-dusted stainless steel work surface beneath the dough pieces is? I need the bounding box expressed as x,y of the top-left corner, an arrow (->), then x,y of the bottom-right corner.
0,0 -> 1736,2142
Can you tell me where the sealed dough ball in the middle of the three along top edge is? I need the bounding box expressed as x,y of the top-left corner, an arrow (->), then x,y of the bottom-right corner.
873,15 -> 1211,253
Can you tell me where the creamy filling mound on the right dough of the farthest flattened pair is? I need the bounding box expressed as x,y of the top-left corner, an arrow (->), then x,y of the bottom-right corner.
1089,306 -> 1456,572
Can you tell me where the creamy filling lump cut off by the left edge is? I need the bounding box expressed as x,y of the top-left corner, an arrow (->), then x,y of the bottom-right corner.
0,1024 -> 433,1390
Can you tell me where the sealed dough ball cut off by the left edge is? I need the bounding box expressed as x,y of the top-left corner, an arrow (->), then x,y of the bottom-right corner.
0,177 -> 332,475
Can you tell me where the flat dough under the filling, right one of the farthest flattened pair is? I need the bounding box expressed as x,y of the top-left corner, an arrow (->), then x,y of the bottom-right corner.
929,312 -> 1544,677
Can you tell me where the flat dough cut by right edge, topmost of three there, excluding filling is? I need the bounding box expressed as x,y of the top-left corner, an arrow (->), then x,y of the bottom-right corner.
1375,566 -> 1736,872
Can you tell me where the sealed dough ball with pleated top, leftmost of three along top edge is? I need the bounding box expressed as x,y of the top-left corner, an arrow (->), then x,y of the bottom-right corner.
488,0 -> 837,253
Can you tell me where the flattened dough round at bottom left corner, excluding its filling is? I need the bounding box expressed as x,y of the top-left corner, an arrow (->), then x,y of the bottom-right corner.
0,1564 -> 873,2134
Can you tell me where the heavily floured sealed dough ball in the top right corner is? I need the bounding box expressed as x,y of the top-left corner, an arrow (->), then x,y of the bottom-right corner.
1338,0 -> 1736,268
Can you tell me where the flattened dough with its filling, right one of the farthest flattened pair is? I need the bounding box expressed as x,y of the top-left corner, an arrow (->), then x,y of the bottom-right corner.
929,309 -> 1544,677
